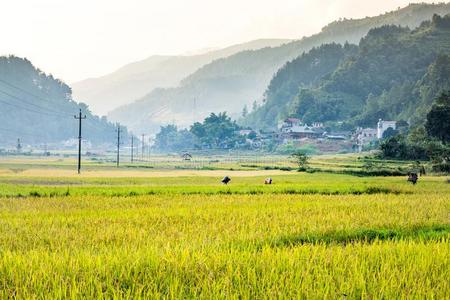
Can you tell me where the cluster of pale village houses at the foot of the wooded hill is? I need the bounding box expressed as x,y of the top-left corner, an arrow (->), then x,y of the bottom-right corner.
240,118 -> 396,152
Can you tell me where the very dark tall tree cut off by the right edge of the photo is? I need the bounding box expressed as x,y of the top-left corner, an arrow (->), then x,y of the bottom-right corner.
425,91 -> 450,143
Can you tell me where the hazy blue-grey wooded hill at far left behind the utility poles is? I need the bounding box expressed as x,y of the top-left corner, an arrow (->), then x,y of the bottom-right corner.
0,56 -> 123,146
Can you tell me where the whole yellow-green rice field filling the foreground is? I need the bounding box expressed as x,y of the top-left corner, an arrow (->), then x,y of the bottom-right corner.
0,157 -> 450,299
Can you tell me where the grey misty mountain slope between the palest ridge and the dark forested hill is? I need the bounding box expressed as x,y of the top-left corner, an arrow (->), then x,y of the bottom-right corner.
109,3 -> 450,132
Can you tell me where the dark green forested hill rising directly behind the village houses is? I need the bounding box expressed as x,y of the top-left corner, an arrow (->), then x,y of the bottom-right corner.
244,15 -> 450,129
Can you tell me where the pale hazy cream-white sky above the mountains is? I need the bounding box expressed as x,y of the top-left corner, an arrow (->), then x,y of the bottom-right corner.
0,0 -> 433,83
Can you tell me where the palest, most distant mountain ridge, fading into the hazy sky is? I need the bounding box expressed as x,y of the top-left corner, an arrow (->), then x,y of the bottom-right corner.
72,39 -> 290,115
